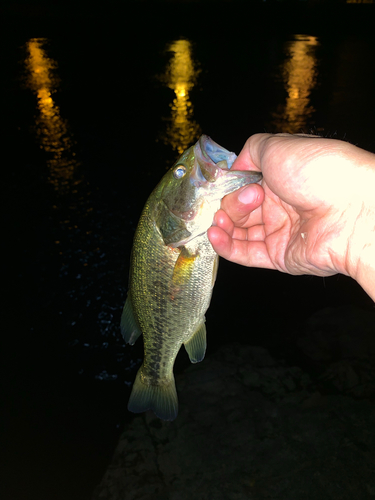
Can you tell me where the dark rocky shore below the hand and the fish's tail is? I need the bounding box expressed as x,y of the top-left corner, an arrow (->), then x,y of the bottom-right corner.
93,307 -> 375,500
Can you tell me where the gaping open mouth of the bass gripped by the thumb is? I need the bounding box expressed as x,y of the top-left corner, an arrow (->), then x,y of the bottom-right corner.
193,135 -> 262,198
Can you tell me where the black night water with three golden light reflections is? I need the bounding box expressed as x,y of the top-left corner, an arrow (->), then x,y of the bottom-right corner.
0,2 -> 375,500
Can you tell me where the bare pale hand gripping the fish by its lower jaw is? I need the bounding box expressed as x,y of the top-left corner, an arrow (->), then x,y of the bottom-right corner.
208,134 -> 375,300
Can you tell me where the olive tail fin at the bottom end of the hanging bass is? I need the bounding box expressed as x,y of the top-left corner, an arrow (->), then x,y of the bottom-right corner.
128,365 -> 178,420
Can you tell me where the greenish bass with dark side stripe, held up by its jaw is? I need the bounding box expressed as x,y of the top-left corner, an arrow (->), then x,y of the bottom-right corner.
121,135 -> 262,421
